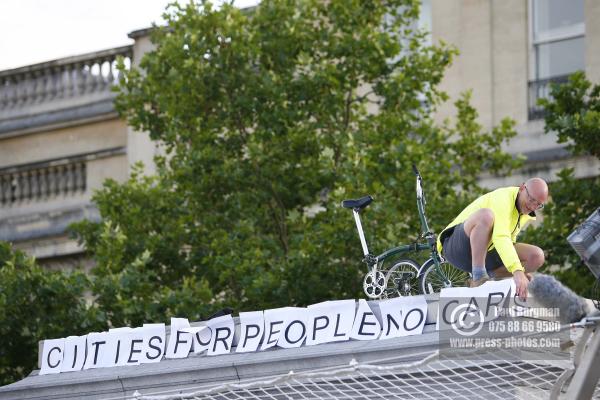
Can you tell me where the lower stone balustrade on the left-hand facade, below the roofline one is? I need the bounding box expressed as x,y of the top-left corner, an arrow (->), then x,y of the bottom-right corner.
0,161 -> 86,206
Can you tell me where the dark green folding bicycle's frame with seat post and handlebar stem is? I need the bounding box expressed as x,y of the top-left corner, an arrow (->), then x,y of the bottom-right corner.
352,165 -> 448,283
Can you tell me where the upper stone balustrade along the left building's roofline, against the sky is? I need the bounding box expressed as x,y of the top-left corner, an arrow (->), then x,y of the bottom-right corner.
0,46 -> 132,119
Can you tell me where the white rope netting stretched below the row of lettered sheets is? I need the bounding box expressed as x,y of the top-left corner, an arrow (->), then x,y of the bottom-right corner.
127,328 -> 600,400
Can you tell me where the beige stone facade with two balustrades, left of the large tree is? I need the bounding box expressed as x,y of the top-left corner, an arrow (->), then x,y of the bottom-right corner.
0,31 -> 156,268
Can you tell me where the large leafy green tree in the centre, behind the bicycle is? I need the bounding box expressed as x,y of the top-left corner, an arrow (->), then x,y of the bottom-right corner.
76,0 -> 518,324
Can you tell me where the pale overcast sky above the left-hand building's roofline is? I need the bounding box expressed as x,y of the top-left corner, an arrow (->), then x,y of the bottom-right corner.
0,0 -> 256,71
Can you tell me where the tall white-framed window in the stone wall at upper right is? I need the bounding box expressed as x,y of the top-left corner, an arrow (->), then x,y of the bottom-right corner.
529,0 -> 585,120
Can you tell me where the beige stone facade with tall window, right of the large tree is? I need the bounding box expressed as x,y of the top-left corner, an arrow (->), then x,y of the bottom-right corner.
432,0 -> 600,187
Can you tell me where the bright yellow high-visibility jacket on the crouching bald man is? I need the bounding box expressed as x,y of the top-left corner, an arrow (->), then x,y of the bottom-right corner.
437,187 -> 536,273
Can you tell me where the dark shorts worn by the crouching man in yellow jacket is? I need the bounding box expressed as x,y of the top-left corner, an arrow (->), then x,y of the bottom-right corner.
442,224 -> 504,272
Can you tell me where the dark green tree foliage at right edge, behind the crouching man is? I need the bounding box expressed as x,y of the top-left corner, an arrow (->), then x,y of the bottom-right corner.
524,72 -> 600,296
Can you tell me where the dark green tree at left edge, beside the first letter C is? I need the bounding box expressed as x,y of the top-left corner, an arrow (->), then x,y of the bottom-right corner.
0,242 -> 95,385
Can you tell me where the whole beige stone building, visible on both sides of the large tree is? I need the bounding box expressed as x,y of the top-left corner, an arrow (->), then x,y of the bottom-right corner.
0,0 -> 600,267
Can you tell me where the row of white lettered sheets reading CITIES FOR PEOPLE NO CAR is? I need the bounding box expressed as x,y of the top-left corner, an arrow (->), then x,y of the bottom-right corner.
40,280 -> 528,375
